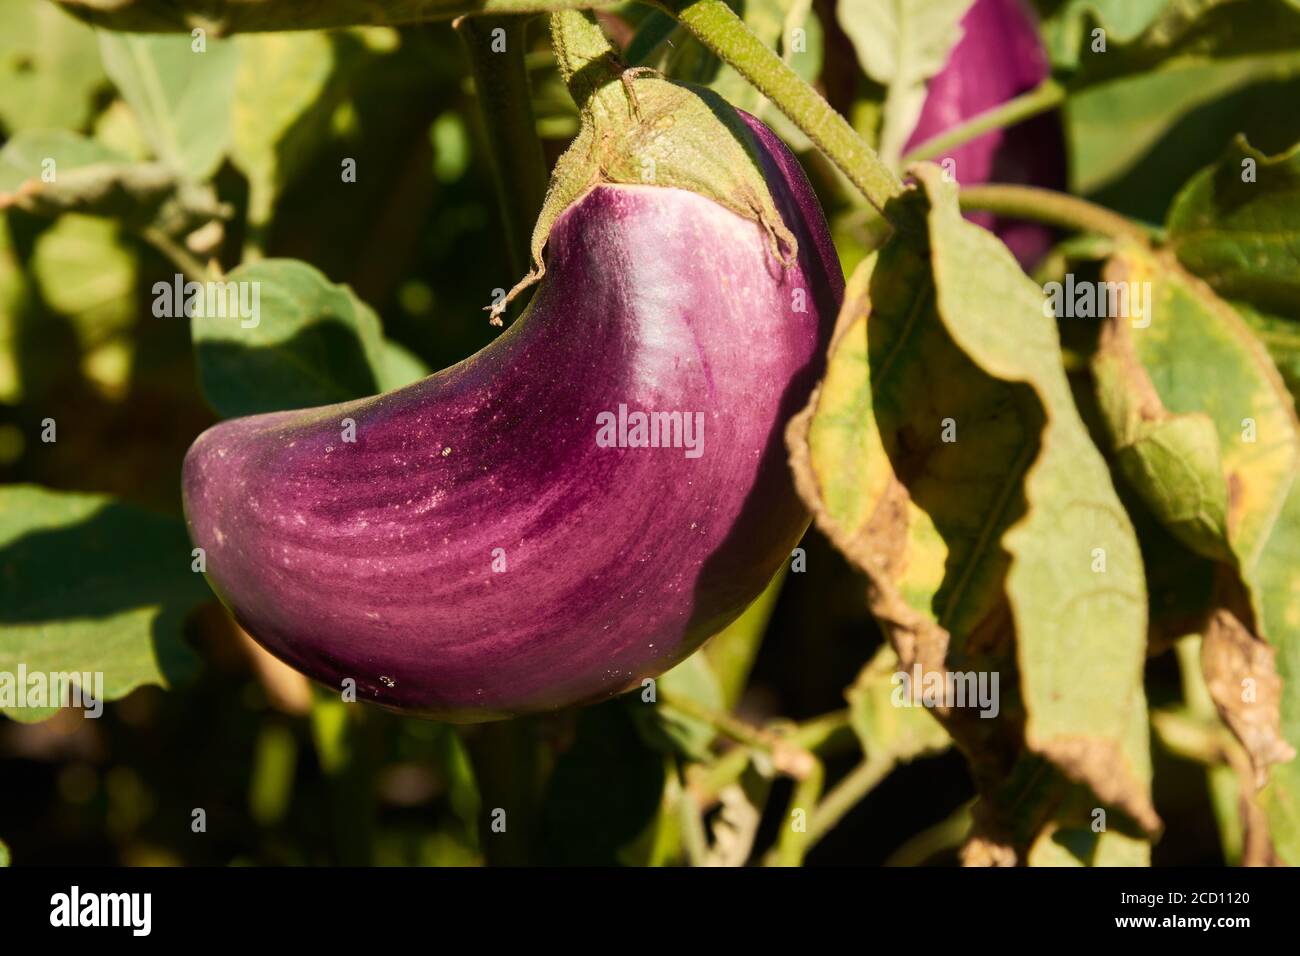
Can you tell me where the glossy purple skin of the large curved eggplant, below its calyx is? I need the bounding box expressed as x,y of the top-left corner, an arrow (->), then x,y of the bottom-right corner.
183,116 -> 844,722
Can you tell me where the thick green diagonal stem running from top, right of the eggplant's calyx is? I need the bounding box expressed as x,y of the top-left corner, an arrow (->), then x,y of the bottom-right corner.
658,0 -> 904,212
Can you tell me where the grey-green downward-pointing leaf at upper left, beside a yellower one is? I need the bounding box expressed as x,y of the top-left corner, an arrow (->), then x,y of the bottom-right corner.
99,31 -> 239,179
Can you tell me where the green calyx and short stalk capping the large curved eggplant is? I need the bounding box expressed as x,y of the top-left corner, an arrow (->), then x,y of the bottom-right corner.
490,10 -> 798,325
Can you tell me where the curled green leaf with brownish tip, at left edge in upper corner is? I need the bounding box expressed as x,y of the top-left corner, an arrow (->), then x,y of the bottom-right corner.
0,130 -> 225,235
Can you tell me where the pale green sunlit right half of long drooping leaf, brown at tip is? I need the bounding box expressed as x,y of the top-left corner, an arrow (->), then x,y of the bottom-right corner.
915,165 -> 1160,831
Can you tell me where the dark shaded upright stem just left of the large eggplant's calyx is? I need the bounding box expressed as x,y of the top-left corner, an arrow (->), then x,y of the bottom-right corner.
452,16 -> 547,274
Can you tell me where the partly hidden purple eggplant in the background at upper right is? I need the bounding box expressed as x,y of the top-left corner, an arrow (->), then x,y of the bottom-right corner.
906,0 -> 1066,265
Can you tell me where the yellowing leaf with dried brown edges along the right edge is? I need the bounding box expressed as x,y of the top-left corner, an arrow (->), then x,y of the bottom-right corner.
1093,245 -> 1300,862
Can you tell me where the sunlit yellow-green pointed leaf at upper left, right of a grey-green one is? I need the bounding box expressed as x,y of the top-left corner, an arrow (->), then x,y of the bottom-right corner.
233,33 -> 334,225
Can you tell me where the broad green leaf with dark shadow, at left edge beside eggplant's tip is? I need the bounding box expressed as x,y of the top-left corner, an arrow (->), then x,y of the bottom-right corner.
0,486 -> 211,721
